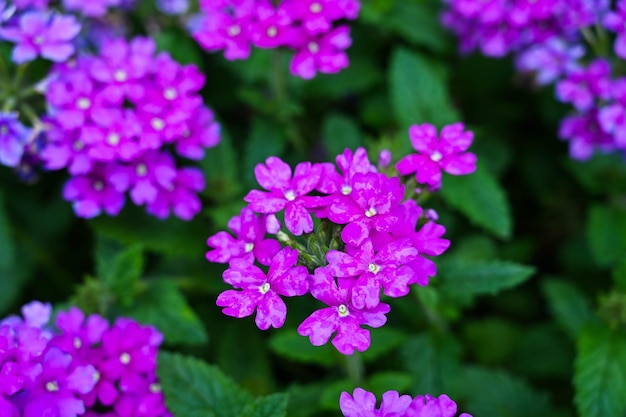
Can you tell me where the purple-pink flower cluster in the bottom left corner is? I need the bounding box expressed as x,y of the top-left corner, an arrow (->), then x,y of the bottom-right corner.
0,302 -> 171,417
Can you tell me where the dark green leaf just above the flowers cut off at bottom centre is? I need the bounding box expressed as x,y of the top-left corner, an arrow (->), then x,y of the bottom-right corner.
400,333 -> 461,393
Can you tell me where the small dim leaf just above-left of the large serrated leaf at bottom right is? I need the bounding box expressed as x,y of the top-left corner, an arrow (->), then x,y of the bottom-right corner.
541,279 -> 594,340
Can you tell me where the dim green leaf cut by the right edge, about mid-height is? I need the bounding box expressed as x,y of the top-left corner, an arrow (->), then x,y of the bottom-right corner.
587,205 -> 626,266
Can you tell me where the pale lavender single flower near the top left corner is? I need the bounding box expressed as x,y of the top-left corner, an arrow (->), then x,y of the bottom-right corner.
0,11 -> 80,64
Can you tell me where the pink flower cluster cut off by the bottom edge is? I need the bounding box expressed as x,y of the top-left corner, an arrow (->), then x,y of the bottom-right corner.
339,388 -> 472,417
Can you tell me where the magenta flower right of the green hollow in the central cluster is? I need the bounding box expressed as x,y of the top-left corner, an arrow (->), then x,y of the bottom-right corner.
328,173 -> 404,246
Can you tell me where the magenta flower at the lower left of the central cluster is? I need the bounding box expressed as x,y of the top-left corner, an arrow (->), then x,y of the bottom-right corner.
217,248 -> 309,330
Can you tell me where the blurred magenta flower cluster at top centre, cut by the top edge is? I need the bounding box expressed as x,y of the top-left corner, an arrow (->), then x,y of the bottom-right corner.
192,0 -> 360,79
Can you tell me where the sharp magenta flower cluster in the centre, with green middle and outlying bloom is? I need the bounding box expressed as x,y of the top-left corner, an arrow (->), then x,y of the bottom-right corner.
207,123 -> 476,354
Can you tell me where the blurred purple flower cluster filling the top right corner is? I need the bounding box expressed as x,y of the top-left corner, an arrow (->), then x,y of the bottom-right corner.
443,0 -> 626,160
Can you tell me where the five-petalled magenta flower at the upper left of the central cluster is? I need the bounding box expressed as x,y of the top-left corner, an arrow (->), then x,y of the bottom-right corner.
244,156 -> 322,236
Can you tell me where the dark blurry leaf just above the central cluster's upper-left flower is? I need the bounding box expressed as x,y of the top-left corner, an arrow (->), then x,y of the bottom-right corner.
242,118 -> 287,188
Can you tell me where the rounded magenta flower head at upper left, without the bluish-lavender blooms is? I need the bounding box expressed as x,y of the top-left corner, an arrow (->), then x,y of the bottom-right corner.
41,38 -> 219,220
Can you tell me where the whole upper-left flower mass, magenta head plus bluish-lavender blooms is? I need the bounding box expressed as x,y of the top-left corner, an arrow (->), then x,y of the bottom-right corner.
0,0 -> 220,220
